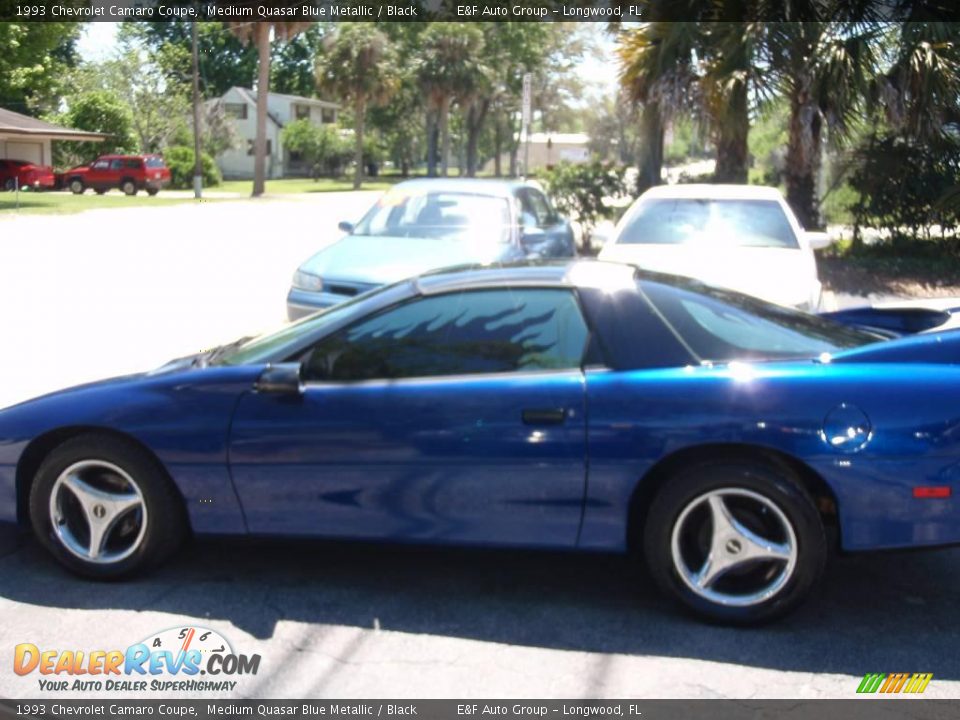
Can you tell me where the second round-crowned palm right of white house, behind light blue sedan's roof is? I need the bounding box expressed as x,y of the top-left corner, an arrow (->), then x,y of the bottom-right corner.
416,22 -> 483,176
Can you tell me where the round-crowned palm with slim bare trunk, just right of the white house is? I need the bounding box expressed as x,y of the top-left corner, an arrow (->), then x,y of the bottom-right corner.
317,23 -> 398,189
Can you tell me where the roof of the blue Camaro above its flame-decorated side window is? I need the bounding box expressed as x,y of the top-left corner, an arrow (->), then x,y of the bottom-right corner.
414,259 -> 638,295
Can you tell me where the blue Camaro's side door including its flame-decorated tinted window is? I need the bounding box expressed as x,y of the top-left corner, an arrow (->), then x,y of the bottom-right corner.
230,288 -> 588,546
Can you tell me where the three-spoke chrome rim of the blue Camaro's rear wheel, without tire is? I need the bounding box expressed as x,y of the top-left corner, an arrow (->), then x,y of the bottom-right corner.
670,487 -> 797,607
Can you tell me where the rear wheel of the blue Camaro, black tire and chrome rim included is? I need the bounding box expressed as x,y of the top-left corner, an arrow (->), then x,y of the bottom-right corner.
644,461 -> 827,625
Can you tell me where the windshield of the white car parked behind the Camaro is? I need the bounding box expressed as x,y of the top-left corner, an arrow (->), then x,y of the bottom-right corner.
617,198 -> 799,248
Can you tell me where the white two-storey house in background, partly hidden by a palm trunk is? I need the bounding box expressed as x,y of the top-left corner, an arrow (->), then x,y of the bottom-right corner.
213,87 -> 340,180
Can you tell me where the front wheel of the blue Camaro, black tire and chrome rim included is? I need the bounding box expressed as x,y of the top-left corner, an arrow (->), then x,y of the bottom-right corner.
30,435 -> 187,578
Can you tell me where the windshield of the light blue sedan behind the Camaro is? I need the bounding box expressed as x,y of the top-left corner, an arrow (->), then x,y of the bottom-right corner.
354,187 -> 511,243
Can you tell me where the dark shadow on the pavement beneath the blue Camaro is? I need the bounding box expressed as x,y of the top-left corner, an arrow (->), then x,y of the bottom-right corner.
0,533 -> 960,680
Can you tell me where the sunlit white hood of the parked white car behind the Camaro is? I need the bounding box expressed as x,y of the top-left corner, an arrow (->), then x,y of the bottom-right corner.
600,243 -> 817,306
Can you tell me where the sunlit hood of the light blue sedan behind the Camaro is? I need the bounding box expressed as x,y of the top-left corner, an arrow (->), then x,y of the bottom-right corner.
300,235 -> 517,285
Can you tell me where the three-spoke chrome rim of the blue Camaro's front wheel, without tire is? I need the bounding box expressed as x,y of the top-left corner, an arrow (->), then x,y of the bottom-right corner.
50,460 -> 147,564
